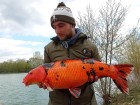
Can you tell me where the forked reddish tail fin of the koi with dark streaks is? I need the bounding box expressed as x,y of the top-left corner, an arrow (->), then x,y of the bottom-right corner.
113,64 -> 133,95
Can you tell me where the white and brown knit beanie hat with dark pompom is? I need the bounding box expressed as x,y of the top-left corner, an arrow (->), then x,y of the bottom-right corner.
50,2 -> 75,26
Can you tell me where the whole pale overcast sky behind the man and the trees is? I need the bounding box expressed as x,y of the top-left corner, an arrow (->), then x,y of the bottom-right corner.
0,0 -> 140,62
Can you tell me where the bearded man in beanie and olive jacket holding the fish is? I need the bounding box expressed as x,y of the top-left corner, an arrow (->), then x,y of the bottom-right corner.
40,2 -> 99,105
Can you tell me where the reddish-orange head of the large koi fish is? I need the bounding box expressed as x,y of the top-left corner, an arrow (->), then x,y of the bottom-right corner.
22,65 -> 47,86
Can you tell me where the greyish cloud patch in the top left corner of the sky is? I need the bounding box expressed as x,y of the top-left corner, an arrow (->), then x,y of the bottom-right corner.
0,0 -> 43,26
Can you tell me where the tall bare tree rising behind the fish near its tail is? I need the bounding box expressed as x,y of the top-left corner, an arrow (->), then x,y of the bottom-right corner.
97,0 -> 127,105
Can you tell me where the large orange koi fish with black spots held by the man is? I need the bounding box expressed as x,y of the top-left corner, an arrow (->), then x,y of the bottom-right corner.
23,59 -> 133,98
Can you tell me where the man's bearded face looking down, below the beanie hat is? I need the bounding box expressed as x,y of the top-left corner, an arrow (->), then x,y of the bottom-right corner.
52,21 -> 75,40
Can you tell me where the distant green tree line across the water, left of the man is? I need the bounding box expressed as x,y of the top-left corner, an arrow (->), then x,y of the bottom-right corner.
0,51 -> 43,73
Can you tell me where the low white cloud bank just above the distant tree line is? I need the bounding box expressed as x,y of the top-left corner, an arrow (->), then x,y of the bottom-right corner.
0,38 -> 44,62
